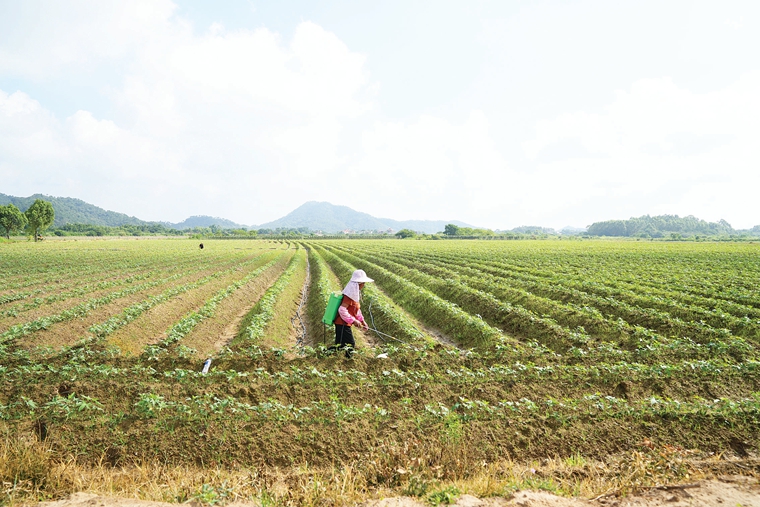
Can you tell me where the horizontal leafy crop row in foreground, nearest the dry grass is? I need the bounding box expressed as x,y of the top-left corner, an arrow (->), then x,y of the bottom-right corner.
7,393 -> 760,426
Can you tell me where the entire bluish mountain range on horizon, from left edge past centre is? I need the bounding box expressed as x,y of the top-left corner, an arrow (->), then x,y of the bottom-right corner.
0,193 -> 471,234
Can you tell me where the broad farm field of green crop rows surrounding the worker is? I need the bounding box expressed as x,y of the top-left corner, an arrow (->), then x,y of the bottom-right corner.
0,239 -> 760,505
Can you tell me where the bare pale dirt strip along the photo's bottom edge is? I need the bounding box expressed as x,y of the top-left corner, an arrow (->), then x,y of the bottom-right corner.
37,477 -> 760,507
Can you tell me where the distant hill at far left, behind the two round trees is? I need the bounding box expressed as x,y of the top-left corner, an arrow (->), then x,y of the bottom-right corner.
0,194 -> 150,227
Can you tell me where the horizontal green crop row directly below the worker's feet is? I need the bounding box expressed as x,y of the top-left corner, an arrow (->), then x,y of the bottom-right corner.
0,361 -> 760,388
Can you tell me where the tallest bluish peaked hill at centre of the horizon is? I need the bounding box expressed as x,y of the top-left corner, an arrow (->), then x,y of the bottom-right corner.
258,201 -> 472,234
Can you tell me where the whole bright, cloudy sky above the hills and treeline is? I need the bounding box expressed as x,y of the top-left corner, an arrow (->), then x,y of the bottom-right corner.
0,0 -> 760,229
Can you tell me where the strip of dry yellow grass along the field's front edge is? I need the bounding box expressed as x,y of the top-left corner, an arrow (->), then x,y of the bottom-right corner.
0,439 -> 757,506
